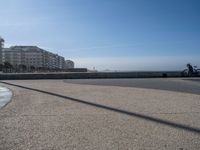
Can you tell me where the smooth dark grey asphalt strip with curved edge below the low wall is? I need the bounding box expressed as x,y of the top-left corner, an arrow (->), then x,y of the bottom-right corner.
65,78 -> 200,94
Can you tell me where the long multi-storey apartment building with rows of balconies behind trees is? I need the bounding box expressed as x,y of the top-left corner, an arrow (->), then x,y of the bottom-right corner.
2,46 -> 65,69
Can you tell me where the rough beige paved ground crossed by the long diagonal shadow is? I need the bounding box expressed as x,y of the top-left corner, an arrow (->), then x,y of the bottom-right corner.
0,79 -> 200,150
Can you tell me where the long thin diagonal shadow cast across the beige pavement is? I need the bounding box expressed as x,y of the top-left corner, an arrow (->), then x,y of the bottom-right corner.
0,81 -> 200,134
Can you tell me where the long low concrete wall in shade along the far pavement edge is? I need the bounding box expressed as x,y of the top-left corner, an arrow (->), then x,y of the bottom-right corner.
0,71 -> 187,80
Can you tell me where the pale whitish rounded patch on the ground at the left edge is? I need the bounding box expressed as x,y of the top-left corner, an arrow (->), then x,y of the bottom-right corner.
0,86 -> 12,108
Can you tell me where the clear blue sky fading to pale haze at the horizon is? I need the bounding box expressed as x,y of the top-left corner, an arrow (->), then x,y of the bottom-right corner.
0,0 -> 200,70
